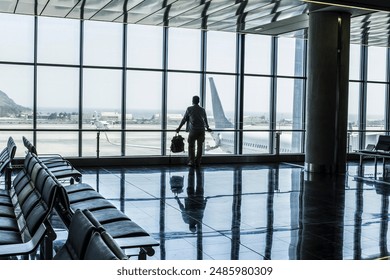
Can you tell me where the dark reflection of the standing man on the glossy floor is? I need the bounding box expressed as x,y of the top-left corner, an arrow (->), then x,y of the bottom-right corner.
176,168 -> 207,232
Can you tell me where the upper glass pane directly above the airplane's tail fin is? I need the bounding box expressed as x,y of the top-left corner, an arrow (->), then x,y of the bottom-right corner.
207,31 -> 236,73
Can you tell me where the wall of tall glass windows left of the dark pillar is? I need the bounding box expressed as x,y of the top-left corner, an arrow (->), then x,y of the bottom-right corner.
0,14 -> 320,160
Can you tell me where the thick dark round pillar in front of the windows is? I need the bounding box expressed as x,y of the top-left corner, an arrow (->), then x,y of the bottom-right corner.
305,11 -> 350,174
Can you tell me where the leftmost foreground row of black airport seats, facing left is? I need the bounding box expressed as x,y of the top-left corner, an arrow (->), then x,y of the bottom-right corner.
0,151 -> 59,259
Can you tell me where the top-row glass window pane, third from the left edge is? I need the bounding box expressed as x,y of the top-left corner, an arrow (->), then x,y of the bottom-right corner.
84,21 -> 123,66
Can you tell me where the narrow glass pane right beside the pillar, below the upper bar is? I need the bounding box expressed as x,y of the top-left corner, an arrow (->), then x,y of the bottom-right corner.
348,83 -> 360,152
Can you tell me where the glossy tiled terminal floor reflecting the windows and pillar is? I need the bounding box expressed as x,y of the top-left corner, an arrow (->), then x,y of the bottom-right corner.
59,163 -> 390,260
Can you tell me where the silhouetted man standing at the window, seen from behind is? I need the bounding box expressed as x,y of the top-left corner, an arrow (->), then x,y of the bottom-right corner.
176,96 -> 211,166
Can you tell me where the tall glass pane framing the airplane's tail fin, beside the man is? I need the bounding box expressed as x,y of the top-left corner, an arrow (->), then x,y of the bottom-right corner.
205,75 -> 236,154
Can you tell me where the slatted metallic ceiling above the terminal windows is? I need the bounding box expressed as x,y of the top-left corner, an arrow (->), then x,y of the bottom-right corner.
0,0 -> 390,47
